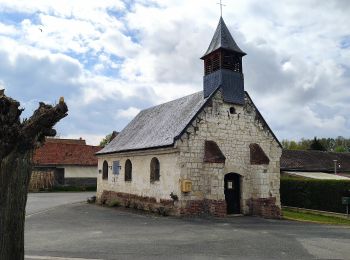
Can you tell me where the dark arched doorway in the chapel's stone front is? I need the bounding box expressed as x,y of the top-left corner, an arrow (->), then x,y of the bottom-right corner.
224,173 -> 241,214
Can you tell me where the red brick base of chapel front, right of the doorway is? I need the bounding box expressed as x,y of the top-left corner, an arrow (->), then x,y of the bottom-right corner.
247,197 -> 282,219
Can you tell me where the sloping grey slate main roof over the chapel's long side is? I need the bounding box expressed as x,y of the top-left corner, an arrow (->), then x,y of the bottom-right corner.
97,91 -> 210,154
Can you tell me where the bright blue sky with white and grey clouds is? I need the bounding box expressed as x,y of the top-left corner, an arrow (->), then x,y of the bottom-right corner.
0,0 -> 350,145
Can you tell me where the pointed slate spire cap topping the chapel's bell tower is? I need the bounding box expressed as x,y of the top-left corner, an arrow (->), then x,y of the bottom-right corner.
202,17 -> 246,59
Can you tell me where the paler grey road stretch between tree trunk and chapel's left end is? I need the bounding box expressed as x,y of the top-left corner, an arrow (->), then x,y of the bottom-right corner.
26,192 -> 95,216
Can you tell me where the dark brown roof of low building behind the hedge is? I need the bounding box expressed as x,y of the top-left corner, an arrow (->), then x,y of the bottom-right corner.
281,150 -> 350,172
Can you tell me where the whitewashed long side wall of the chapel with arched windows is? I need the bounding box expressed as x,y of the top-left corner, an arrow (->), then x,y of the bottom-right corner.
97,148 -> 180,202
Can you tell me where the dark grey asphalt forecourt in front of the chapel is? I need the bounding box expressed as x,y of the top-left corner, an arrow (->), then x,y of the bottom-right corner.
25,194 -> 350,260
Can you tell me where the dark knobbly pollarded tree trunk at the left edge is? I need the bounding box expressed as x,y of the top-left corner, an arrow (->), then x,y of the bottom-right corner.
0,91 -> 68,260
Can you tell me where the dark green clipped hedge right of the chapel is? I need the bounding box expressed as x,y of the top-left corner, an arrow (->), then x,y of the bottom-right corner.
281,178 -> 350,213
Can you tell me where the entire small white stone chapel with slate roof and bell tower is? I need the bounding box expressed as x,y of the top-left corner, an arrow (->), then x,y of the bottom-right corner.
97,17 -> 282,218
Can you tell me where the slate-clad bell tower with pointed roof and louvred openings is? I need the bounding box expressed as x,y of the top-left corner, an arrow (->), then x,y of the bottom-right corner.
201,17 -> 246,105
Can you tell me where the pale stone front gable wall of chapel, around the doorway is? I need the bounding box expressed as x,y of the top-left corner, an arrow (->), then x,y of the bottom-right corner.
176,91 -> 282,217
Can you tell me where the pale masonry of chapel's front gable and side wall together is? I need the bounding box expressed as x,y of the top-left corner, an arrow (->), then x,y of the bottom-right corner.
97,91 -> 282,218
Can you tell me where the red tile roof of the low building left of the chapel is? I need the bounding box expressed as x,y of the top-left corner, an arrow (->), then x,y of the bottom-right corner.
33,138 -> 102,166
